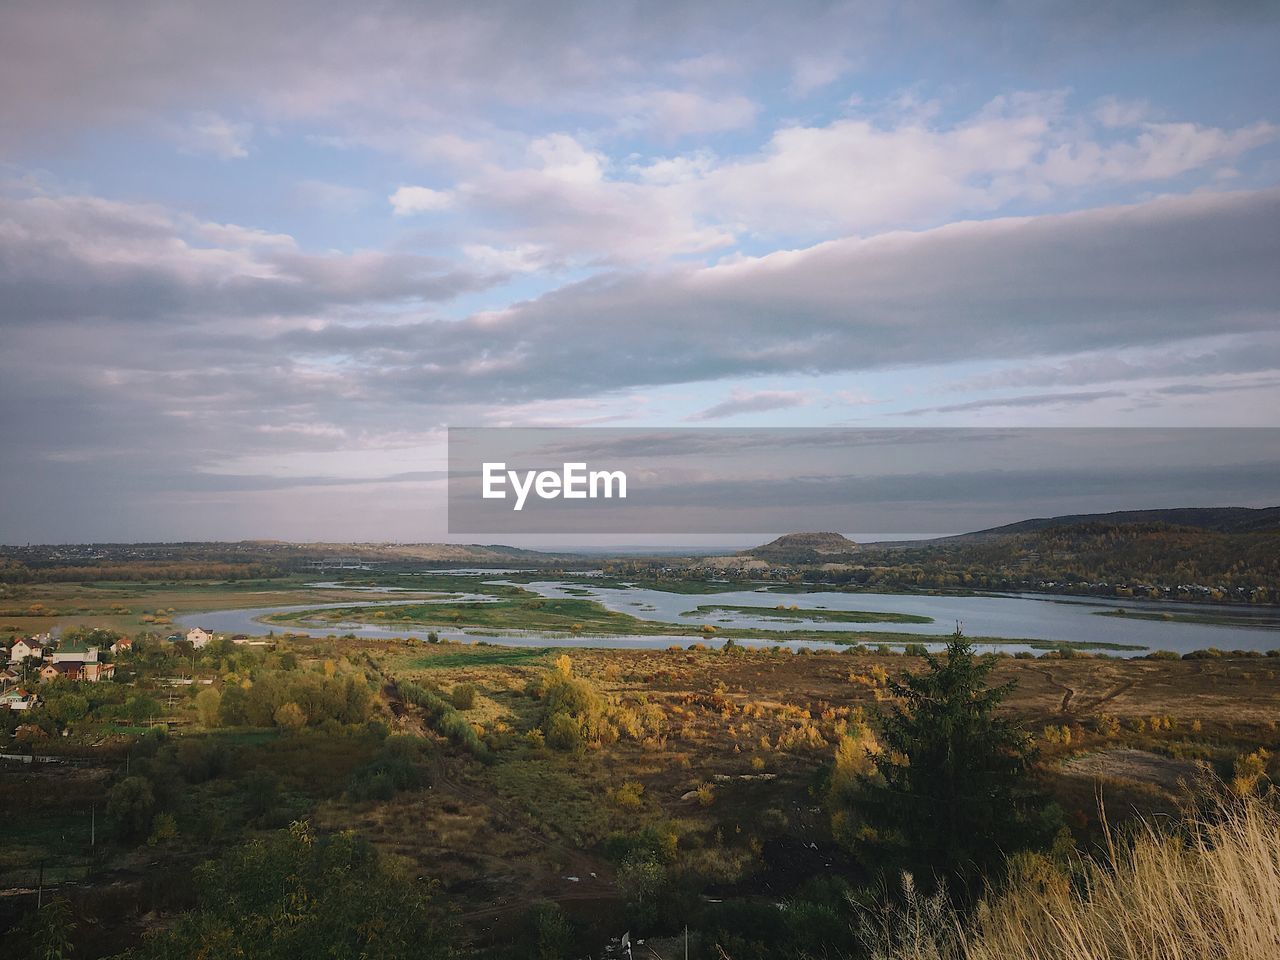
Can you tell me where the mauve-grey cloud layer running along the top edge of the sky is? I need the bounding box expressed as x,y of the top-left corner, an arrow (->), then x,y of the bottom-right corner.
0,0 -> 1277,155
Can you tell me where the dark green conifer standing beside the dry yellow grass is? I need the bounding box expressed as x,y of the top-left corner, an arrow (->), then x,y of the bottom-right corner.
858,628 -> 1038,887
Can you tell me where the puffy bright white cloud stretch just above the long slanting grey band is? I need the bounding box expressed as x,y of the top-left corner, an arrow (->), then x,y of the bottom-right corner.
428,93 -> 1280,264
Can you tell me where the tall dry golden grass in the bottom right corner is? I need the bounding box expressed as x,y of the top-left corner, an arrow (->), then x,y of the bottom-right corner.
861,800 -> 1280,960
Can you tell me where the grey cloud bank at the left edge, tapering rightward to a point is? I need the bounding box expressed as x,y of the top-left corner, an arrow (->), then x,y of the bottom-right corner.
0,196 -> 499,325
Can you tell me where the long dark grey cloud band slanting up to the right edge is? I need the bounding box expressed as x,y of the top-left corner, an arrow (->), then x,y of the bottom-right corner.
267,191 -> 1280,402
